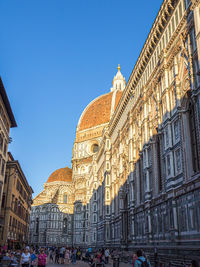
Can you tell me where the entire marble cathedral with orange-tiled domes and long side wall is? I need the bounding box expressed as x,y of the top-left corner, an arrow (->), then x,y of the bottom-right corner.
30,0 -> 200,264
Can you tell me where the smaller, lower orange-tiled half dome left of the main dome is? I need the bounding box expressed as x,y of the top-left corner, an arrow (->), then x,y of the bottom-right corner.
47,167 -> 72,183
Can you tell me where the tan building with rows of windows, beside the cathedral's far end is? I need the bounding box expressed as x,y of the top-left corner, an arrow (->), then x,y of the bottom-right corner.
0,152 -> 33,248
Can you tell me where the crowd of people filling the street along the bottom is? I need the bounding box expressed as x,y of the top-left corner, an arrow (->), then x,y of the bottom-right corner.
0,246 -> 200,267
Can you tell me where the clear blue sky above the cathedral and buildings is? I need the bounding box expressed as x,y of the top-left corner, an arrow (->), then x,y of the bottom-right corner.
0,0 -> 162,196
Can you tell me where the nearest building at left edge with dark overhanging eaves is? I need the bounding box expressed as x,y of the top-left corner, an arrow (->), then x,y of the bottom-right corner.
0,77 -> 17,228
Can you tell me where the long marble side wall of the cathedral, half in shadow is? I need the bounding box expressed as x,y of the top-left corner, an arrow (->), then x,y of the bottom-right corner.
88,1 -> 200,258
